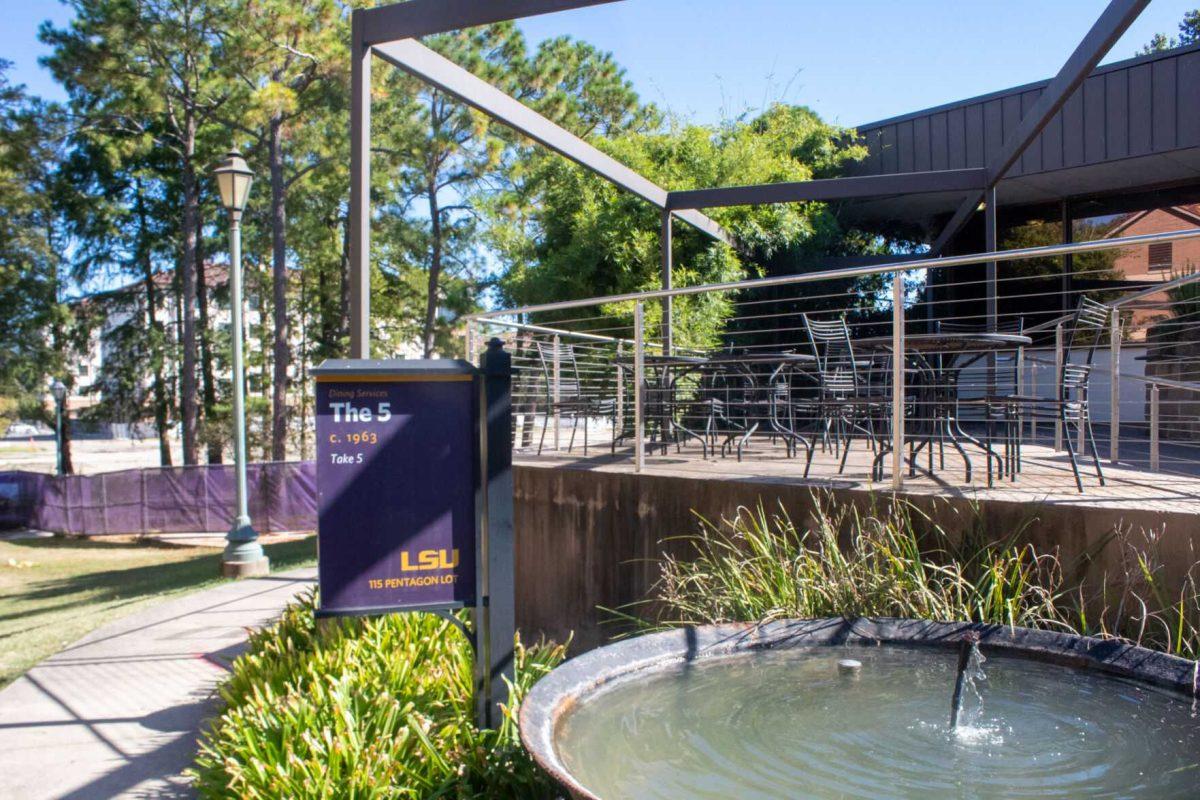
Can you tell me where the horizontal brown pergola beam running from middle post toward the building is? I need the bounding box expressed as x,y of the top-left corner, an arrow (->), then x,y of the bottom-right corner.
667,167 -> 988,211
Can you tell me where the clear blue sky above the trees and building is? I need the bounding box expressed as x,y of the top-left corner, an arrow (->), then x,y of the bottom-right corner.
0,0 -> 1200,125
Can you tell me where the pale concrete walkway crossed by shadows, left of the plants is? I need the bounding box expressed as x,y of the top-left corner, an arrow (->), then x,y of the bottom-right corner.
0,569 -> 316,800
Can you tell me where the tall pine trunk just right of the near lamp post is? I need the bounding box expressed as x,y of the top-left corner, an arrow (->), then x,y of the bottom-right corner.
268,115 -> 292,461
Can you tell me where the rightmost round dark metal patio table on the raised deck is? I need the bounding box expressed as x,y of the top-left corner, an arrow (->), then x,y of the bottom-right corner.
853,332 -> 1033,486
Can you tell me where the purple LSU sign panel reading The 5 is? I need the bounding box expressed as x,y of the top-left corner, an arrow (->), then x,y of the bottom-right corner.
313,361 -> 479,614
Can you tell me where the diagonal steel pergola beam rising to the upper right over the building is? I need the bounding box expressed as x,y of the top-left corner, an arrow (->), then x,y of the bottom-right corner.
930,0 -> 1150,255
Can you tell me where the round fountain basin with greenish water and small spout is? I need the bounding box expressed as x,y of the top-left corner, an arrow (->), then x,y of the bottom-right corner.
521,619 -> 1200,800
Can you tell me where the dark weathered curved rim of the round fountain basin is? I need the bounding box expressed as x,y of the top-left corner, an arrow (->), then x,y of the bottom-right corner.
520,618 -> 1200,800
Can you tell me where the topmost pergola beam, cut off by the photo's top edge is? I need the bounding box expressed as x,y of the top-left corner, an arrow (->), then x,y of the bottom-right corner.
360,0 -> 617,46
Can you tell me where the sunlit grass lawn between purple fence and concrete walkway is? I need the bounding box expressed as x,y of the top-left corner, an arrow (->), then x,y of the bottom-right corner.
0,536 -> 317,686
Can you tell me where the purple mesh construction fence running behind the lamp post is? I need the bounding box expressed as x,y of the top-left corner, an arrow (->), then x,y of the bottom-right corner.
0,461 -> 317,536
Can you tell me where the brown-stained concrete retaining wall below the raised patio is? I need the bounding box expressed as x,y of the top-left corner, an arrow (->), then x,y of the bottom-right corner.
515,464 -> 1200,650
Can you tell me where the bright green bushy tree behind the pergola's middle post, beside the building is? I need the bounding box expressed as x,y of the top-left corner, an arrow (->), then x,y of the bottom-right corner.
492,106 -> 862,347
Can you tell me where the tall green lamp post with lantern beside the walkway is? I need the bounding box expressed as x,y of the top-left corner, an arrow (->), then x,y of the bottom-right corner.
214,150 -> 269,578
